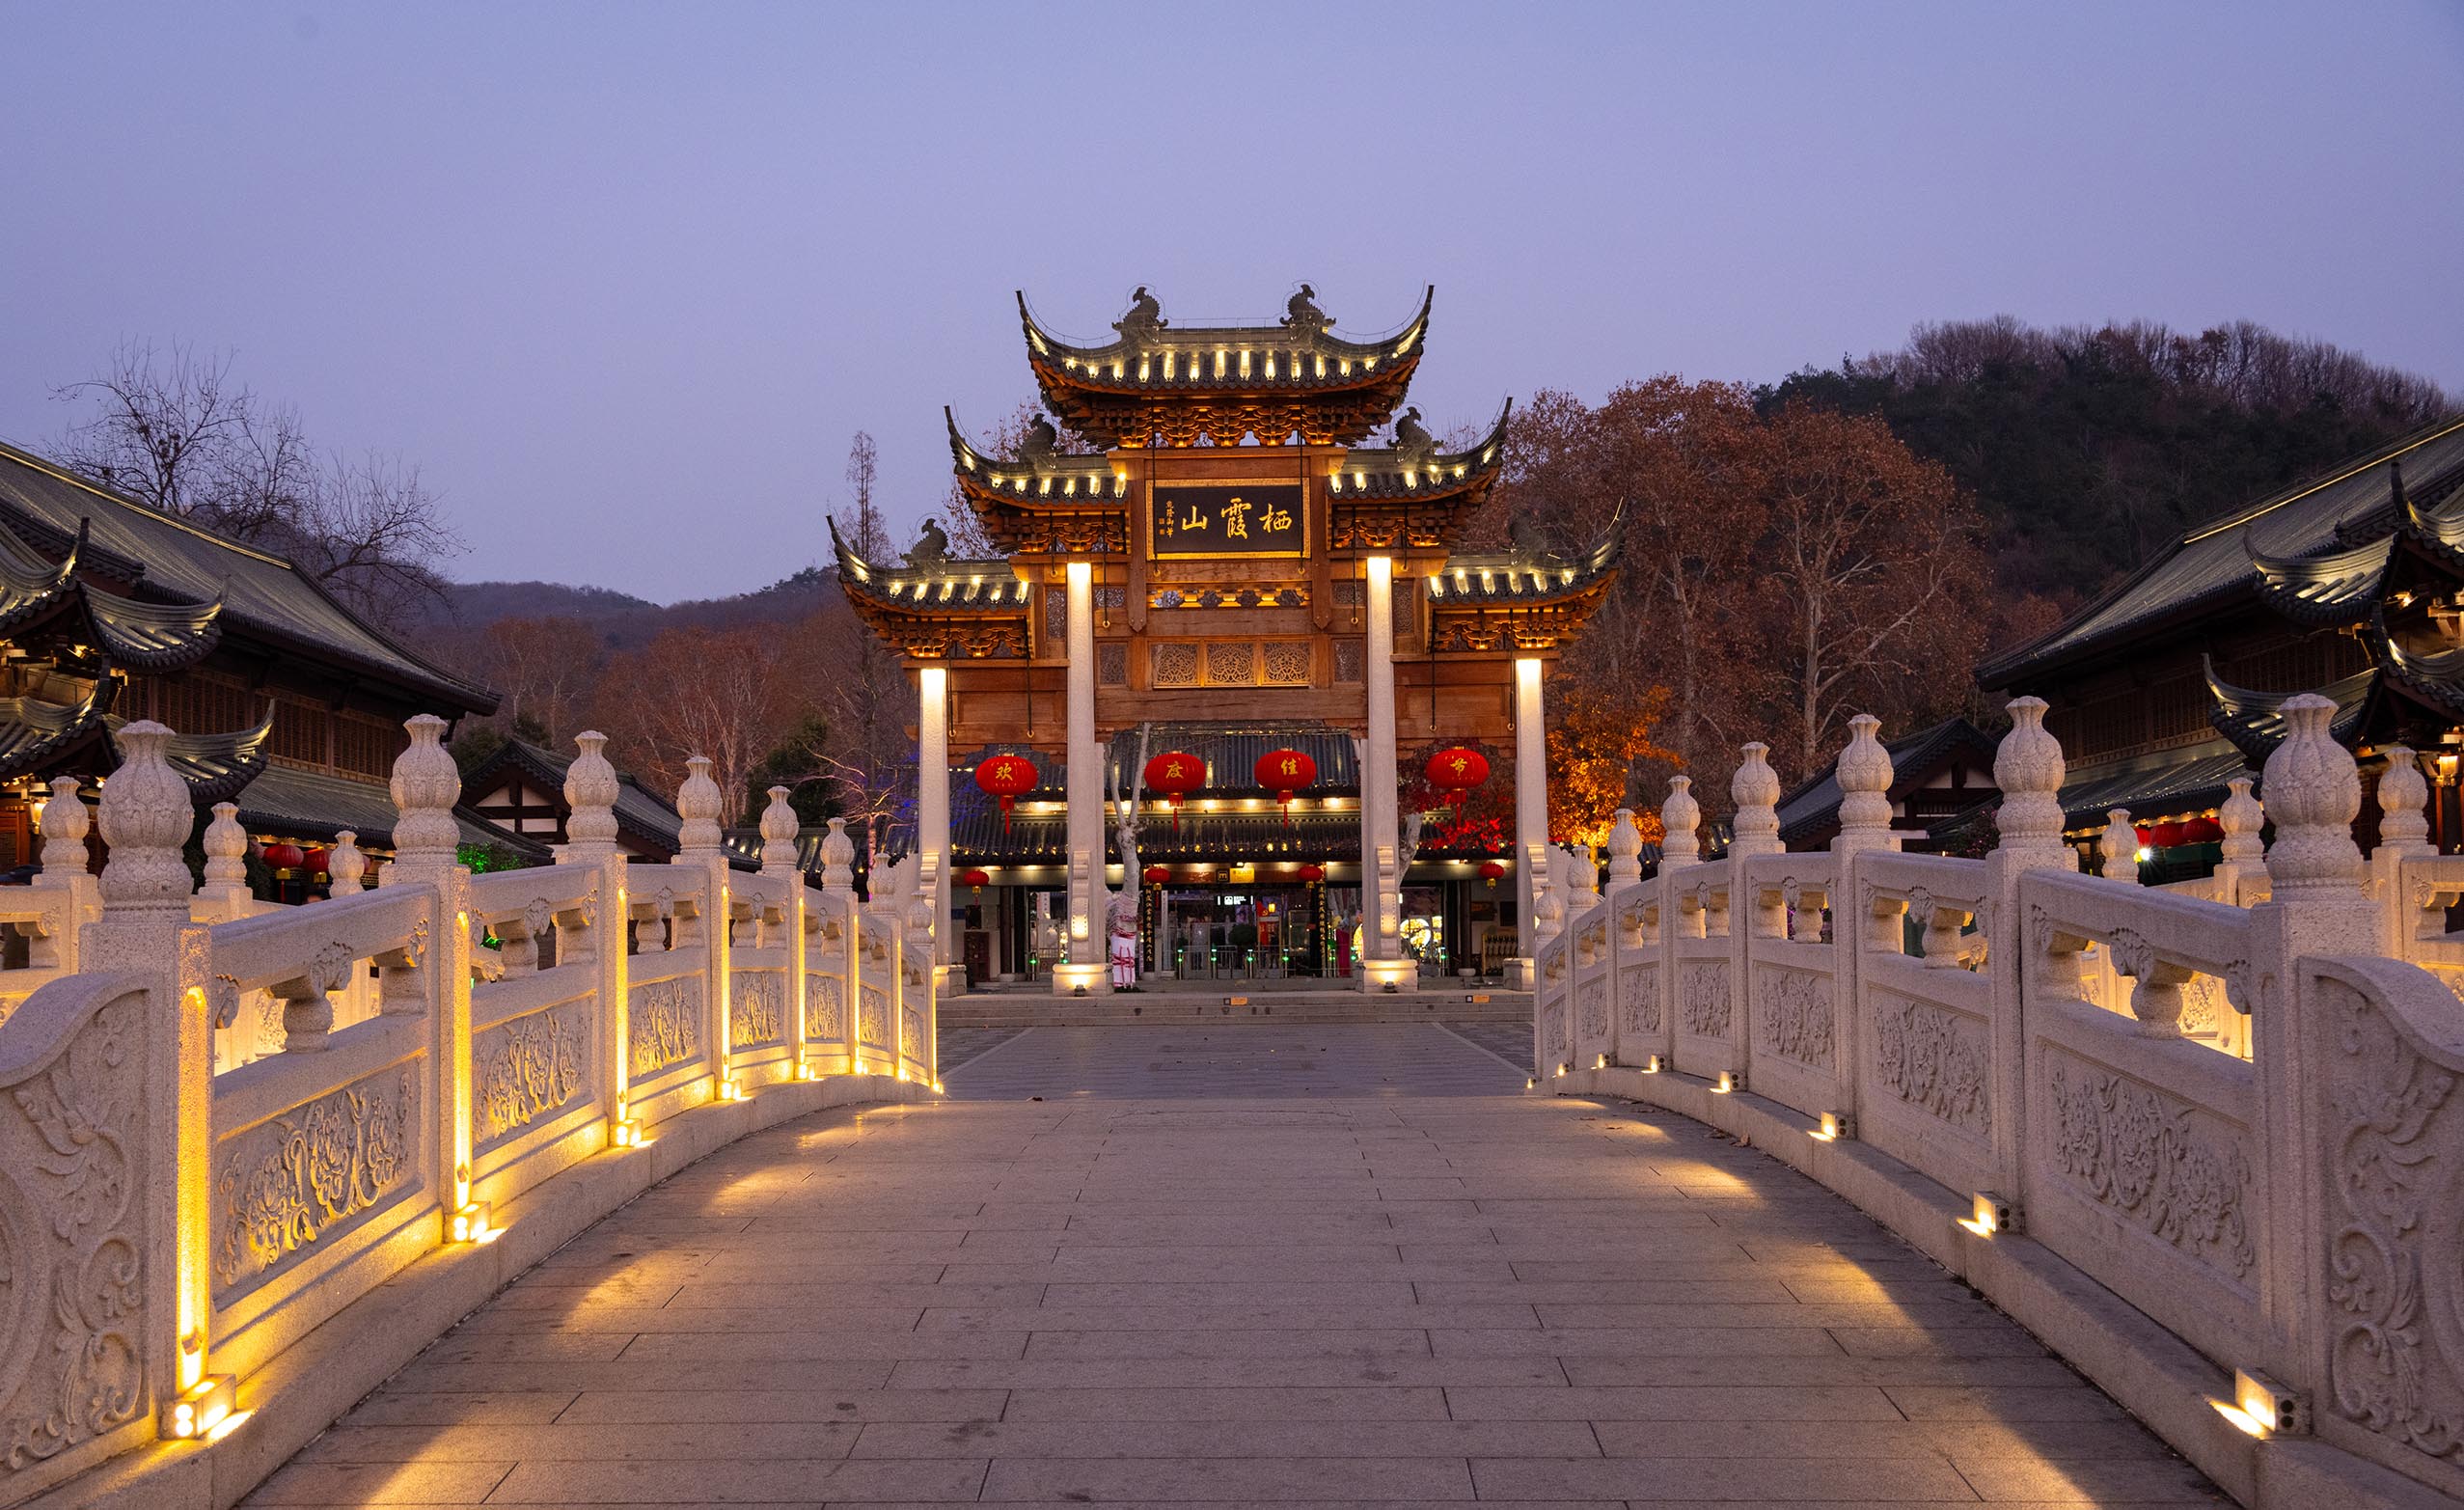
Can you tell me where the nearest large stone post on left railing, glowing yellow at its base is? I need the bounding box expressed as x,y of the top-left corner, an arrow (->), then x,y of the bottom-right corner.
81,719 -> 214,1397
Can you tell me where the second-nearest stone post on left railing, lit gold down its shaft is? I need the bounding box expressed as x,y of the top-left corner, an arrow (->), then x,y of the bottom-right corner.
379,712 -> 471,1236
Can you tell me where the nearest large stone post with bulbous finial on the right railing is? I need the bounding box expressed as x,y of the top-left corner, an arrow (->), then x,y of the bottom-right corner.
2225,692 -> 2380,1397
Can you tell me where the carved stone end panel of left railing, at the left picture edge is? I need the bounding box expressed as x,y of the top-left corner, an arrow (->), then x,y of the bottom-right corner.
0,1001 -> 152,1468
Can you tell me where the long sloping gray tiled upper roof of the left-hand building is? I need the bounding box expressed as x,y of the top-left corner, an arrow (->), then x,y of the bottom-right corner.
0,444 -> 495,717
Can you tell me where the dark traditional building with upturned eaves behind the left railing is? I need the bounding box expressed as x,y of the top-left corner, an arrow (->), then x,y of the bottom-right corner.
0,446 -> 512,881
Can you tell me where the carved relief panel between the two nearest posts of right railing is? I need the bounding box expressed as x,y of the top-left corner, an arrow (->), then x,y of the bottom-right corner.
2045,1052 -> 2259,1281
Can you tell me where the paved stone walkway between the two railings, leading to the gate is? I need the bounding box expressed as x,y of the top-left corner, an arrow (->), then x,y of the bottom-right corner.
249,1025 -> 2220,1510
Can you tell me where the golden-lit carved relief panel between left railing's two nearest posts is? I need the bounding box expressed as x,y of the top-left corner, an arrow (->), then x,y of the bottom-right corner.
212,1069 -> 419,1304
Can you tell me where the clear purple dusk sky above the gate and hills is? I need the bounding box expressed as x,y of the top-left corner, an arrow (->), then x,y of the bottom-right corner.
0,0 -> 2464,601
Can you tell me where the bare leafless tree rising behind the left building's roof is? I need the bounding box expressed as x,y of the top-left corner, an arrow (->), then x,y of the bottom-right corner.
52,343 -> 463,618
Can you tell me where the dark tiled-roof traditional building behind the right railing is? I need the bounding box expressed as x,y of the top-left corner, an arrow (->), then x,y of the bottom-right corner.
1976,422 -> 2464,879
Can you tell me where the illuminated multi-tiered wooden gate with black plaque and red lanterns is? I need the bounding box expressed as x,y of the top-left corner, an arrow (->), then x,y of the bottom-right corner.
833,284 -> 1616,990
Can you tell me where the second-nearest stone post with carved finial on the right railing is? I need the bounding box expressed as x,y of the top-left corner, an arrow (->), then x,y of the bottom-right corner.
1979,698 -> 2080,1193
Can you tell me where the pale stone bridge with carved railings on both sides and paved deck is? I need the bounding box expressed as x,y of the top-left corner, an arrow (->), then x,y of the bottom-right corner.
0,698 -> 2464,1510
